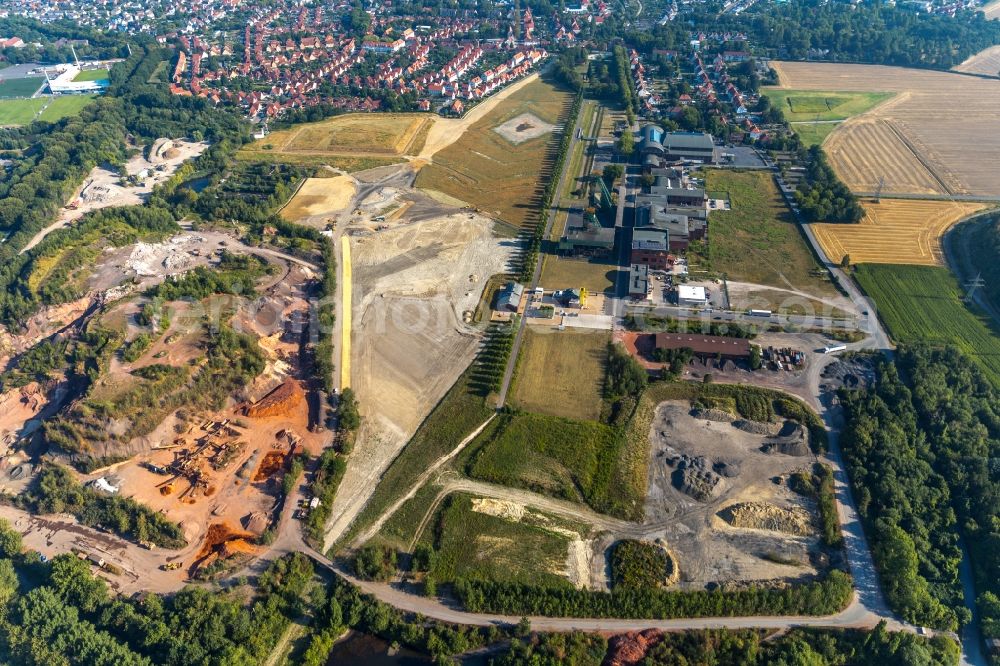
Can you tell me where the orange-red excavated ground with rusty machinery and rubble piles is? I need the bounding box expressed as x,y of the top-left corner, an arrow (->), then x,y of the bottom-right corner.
106,379 -> 320,578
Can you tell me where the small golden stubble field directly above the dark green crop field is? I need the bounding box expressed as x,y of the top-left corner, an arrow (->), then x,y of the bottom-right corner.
812,199 -> 986,266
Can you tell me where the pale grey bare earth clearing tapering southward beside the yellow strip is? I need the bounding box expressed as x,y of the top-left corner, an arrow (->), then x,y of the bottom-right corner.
327,208 -> 514,542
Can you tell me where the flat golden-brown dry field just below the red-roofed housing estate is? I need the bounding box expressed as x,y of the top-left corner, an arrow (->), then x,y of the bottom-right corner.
248,113 -> 434,156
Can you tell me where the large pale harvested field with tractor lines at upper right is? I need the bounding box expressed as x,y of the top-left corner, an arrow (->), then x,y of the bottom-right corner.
771,62 -> 1000,196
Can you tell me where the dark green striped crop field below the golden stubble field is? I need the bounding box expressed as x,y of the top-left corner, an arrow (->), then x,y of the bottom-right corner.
854,264 -> 1000,386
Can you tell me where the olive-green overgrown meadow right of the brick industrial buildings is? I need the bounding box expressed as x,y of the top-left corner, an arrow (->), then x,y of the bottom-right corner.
705,169 -> 837,296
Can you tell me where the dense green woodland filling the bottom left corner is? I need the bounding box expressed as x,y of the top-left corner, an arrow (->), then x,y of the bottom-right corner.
0,521 -> 313,666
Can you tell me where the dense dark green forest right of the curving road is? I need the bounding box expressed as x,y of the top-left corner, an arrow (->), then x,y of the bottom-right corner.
842,347 -> 1000,637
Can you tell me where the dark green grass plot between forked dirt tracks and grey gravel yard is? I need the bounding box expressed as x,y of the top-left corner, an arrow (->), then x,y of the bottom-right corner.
467,412 -> 645,517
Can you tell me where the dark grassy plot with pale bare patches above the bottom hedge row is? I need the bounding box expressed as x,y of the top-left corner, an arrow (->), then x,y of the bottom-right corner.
421,495 -> 569,587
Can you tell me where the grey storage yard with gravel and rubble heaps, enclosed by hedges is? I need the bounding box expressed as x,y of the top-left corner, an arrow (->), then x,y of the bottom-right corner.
646,401 -> 819,588
